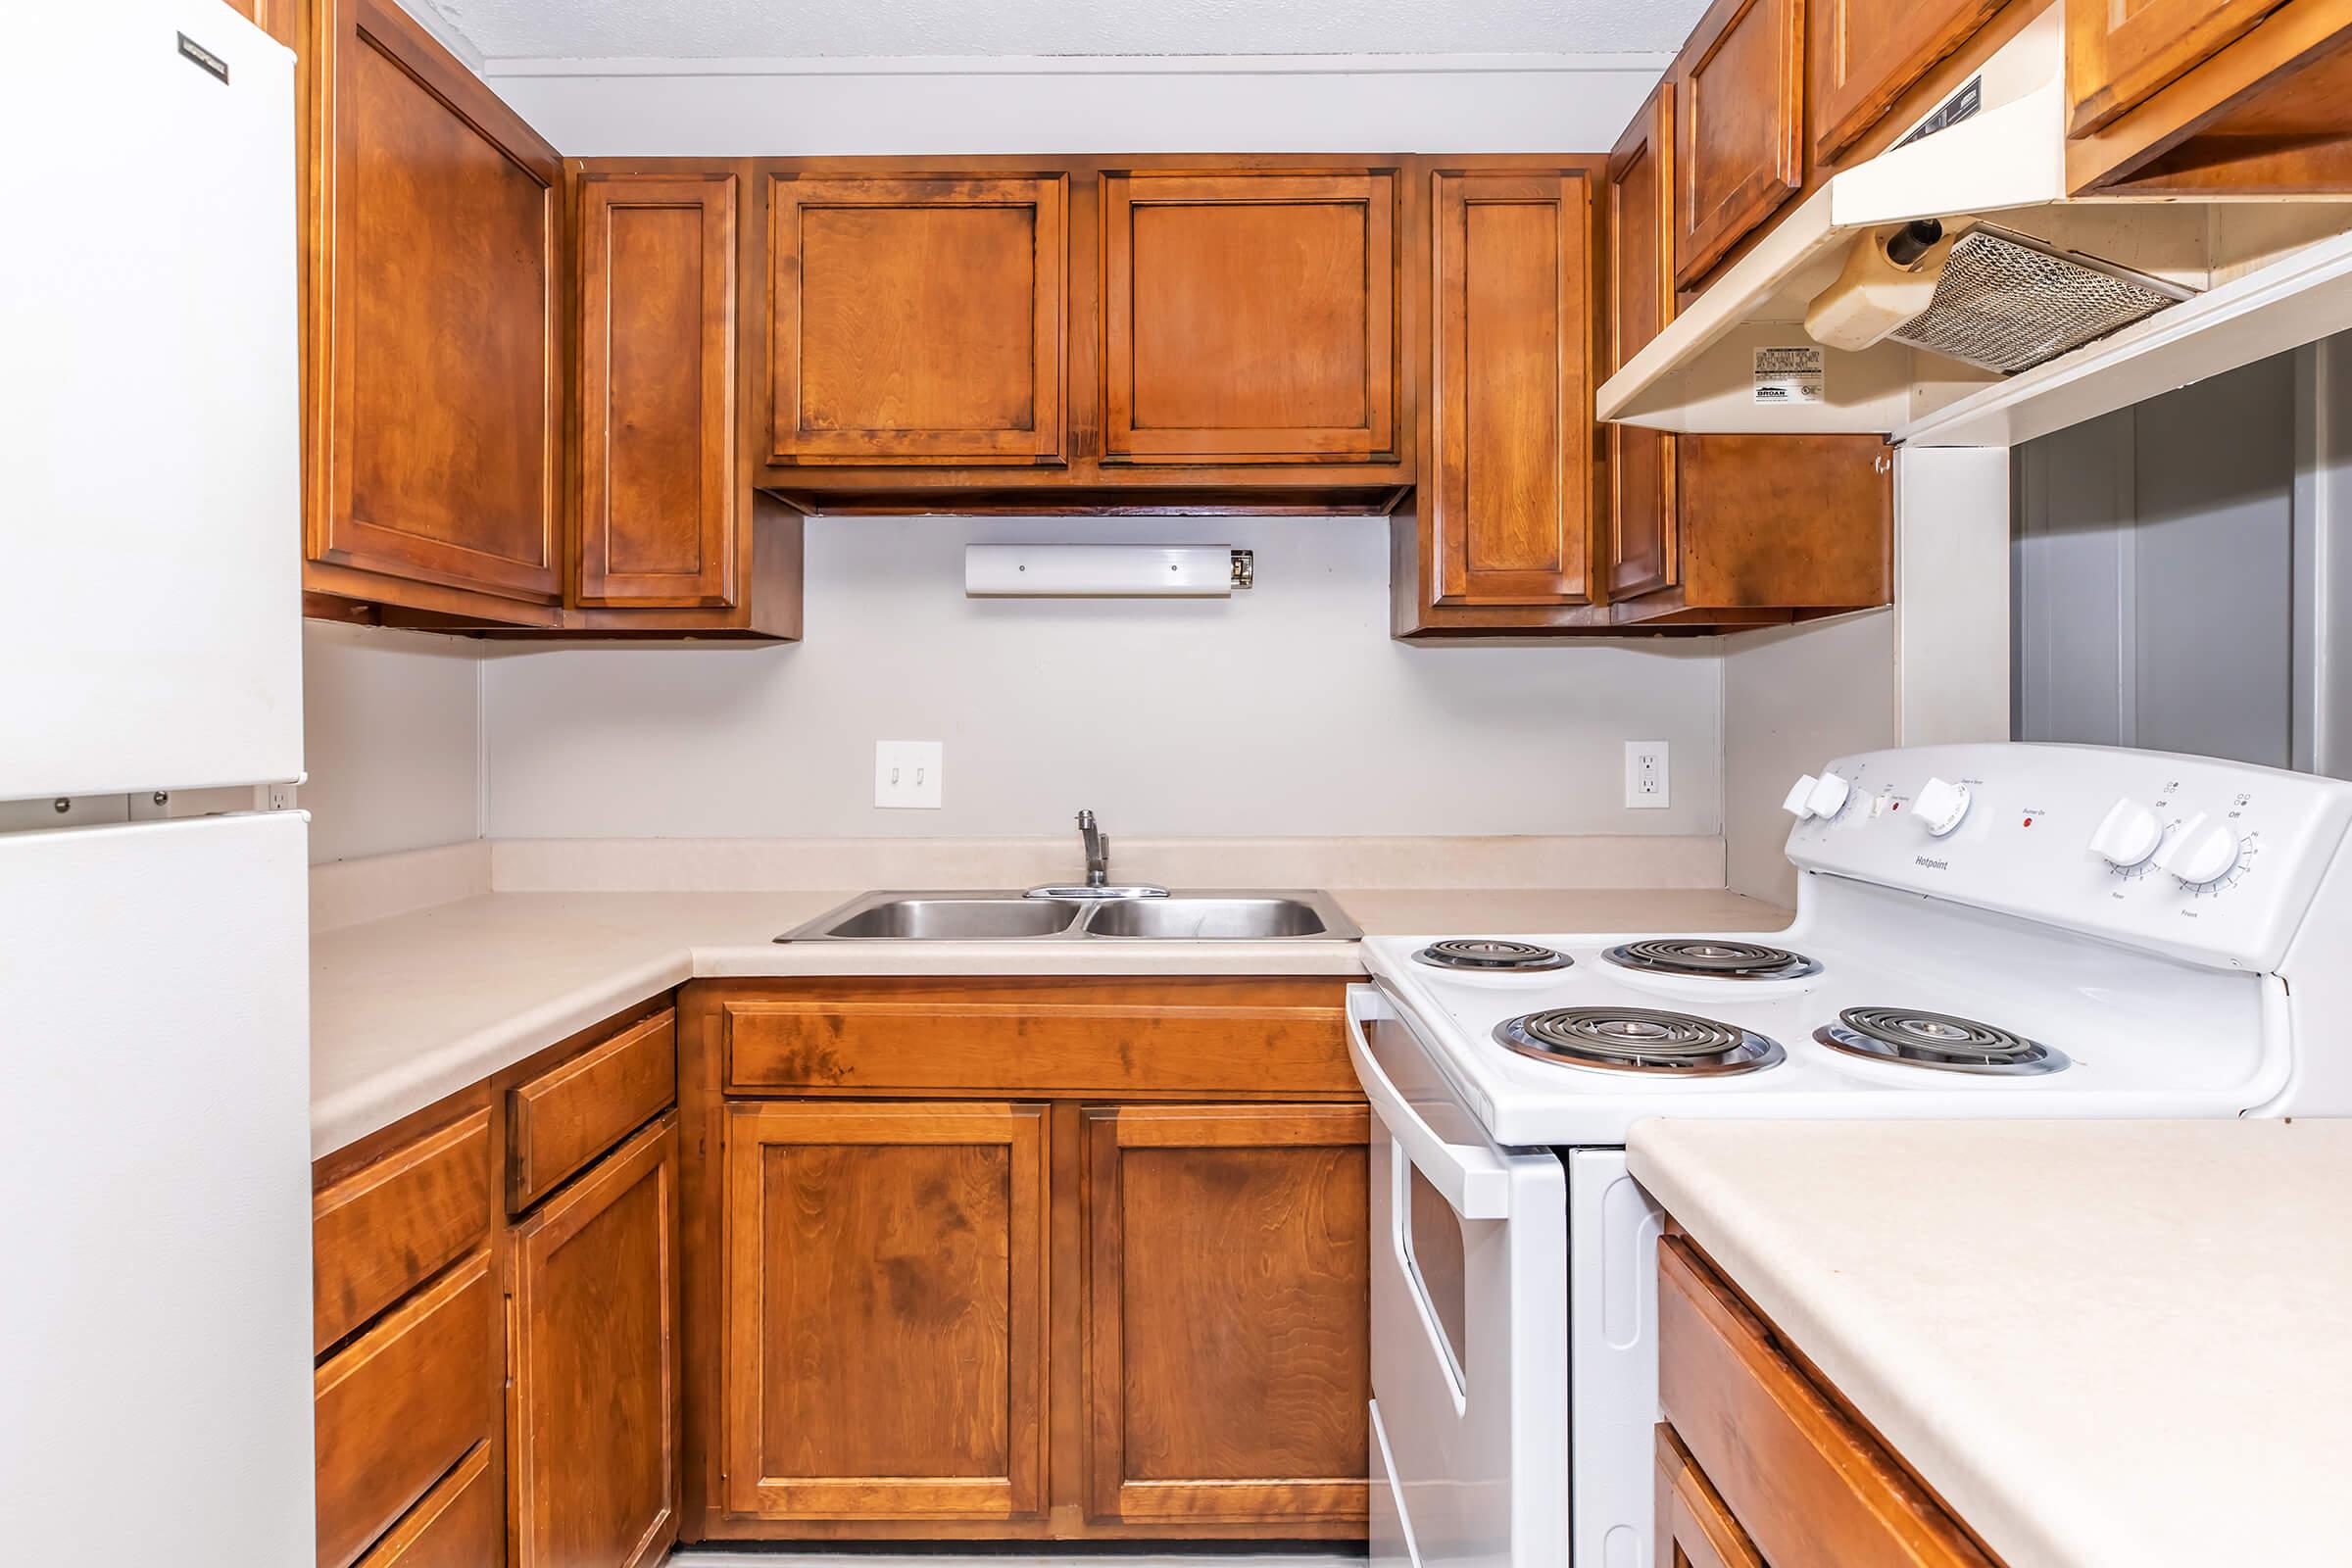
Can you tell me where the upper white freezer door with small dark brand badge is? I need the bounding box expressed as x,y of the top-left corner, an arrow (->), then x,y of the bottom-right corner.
0,0 -> 301,800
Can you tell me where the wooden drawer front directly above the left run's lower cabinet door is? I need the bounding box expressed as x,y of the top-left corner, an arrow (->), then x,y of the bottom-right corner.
506,1010 -> 677,1210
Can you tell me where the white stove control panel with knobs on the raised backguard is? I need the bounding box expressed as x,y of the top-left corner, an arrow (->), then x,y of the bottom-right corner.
1788,743 -> 2352,971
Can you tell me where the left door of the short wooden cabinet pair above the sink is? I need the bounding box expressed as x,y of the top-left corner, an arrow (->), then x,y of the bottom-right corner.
769,174 -> 1070,466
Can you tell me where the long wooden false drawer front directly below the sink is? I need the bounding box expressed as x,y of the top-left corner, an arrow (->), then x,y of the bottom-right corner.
724,978 -> 1357,1096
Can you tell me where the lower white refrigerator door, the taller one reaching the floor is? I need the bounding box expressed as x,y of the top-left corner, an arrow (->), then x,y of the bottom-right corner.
0,811 -> 318,1568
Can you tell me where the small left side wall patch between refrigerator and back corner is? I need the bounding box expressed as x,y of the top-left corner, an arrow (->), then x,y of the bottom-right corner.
296,620 -> 482,865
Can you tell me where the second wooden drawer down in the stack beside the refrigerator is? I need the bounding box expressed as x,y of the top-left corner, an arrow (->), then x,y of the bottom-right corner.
318,1250 -> 496,1568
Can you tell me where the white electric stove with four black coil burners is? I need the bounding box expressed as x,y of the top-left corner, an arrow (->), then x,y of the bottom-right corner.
1350,745 -> 2352,1568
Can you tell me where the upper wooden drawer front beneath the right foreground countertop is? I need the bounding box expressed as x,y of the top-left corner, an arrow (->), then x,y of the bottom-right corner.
1658,1237 -> 1989,1568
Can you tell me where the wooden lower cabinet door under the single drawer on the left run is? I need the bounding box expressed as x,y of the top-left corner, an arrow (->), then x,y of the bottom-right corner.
508,1112 -> 680,1568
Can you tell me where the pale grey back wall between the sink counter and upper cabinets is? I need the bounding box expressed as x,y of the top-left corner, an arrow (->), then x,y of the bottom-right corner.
484,517 -> 1719,837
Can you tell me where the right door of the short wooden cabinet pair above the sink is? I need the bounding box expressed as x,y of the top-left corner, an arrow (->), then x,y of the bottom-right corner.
1103,170 -> 1397,464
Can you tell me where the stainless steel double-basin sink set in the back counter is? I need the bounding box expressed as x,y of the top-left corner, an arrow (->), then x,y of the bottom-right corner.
776,891 -> 1364,943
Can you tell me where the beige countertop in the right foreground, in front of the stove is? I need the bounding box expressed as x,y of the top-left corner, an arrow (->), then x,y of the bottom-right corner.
1630,1121 -> 2352,1568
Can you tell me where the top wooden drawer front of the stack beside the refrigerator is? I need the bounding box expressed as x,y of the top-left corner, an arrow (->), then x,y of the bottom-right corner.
311,1109 -> 489,1354
